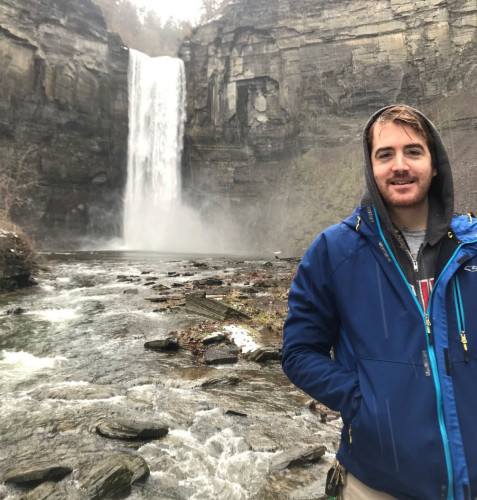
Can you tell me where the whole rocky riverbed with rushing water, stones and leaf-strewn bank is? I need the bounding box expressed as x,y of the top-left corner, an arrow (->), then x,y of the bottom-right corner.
0,253 -> 341,500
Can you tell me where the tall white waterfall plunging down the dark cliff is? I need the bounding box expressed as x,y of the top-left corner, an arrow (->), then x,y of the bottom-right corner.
123,49 -> 185,251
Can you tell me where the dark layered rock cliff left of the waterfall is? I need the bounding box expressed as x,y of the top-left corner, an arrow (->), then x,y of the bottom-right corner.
0,0 -> 128,246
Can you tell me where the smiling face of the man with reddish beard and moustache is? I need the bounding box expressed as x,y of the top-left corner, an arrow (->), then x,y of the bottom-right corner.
371,122 -> 437,209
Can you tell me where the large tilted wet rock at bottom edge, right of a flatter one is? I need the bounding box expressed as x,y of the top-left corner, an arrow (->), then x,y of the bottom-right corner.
79,453 -> 149,500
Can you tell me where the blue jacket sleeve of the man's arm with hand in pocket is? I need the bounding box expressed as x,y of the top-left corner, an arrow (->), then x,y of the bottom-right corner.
282,233 -> 361,423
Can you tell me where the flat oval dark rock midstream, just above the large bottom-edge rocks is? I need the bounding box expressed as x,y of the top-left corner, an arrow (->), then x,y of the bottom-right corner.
96,418 -> 169,441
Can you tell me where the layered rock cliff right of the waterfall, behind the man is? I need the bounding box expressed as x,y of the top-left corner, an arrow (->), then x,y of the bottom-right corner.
182,0 -> 477,252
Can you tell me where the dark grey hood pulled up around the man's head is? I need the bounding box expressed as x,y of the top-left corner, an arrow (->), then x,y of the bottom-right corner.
361,106 -> 454,245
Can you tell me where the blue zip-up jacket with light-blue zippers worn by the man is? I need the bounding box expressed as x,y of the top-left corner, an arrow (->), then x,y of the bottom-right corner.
283,205 -> 477,500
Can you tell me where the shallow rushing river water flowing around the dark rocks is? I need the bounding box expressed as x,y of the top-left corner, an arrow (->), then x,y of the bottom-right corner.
0,252 -> 340,500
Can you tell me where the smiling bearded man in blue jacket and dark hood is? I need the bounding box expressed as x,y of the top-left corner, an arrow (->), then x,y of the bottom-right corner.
283,106 -> 477,500
